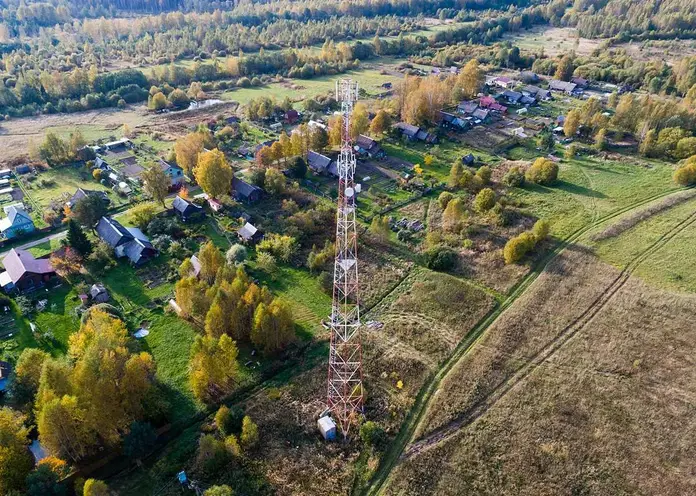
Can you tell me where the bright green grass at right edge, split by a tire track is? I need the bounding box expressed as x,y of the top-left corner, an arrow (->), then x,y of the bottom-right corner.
591,195 -> 696,293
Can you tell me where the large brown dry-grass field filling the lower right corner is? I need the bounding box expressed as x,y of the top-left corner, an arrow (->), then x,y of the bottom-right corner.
386,272 -> 696,496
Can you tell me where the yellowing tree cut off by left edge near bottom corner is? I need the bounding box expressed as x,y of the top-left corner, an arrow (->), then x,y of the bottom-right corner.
0,407 -> 34,494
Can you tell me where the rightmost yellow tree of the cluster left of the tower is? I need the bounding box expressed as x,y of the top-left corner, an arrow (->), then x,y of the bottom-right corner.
251,298 -> 295,355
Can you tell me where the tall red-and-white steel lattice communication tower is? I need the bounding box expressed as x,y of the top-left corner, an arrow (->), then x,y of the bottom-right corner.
327,79 -> 363,437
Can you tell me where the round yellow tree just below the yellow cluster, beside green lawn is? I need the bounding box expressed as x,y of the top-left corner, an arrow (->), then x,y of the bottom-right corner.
190,334 -> 239,403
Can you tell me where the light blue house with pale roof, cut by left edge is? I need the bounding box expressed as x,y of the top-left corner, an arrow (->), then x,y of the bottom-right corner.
0,248 -> 56,292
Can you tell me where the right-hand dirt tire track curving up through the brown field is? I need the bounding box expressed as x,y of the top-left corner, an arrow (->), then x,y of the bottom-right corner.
401,212 -> 696,459
